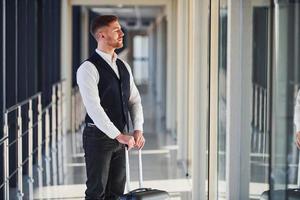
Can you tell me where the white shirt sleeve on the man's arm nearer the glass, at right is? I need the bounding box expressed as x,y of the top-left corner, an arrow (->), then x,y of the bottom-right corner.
123,61 -> 144,131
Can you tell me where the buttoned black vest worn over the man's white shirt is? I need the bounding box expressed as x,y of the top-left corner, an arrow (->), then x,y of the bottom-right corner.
85,52 -> 130,132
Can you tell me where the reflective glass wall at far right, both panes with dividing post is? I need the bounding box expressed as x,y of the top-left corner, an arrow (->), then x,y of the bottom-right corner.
249,1 -> 300,199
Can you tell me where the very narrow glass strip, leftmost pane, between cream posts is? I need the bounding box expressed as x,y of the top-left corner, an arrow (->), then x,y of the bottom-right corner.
218,1 -> 227,199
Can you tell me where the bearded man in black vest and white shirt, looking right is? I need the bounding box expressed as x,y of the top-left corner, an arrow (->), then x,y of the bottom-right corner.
77,15 -> 145,200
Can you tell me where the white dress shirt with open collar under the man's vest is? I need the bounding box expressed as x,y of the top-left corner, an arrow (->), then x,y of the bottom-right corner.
76,49 -> 144,139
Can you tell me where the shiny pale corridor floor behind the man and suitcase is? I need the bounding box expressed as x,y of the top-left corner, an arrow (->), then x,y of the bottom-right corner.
34,83 -> 192,200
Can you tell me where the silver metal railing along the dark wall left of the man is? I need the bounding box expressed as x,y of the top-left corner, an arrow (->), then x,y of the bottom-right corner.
0,81 -> 66,200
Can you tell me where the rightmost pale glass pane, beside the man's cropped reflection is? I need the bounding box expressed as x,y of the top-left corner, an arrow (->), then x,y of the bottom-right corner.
271,0 -> 300,199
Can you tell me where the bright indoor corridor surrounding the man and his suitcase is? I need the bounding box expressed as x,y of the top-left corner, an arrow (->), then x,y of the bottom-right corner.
0,0 -> 300,200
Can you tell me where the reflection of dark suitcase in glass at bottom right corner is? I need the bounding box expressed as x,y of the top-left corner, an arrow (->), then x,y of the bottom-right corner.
260,188 -> 300,200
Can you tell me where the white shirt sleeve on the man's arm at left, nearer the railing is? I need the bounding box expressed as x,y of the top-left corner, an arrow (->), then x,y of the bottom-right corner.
76,61 -> 120,139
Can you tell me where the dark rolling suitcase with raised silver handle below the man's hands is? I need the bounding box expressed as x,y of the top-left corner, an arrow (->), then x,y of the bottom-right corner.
119,148 -> 170,200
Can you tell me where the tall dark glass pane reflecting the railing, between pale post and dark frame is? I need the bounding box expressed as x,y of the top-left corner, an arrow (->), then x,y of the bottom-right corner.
249,7 -> 270,199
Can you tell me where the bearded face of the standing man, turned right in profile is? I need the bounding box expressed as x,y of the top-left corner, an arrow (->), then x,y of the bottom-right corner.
100,21 -> 124,49
